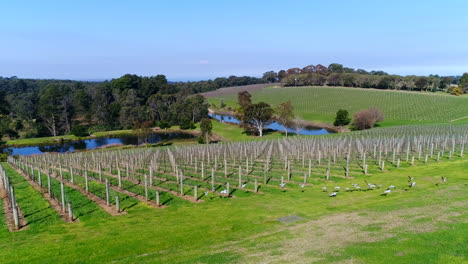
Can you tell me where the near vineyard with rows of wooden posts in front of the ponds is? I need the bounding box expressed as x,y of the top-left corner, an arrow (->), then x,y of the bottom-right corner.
0,124 -> 468,261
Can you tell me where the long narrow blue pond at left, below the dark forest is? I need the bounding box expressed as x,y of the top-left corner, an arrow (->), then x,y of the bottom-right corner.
7,133 -> 194,156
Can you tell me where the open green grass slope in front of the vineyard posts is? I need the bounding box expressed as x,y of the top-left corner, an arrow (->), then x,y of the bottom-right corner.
0,157 -> 468,263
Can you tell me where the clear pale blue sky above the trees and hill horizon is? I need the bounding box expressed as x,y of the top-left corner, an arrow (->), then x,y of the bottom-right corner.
0,0 -> 468,80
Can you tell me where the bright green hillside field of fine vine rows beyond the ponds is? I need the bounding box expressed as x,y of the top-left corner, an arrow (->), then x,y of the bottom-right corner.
209,87 -> 468,126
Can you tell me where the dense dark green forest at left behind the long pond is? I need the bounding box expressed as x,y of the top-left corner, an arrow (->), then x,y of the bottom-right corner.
0,74 -> 264,138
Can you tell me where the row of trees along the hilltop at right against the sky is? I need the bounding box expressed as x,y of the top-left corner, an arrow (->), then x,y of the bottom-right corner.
263,63 -> 468,93
